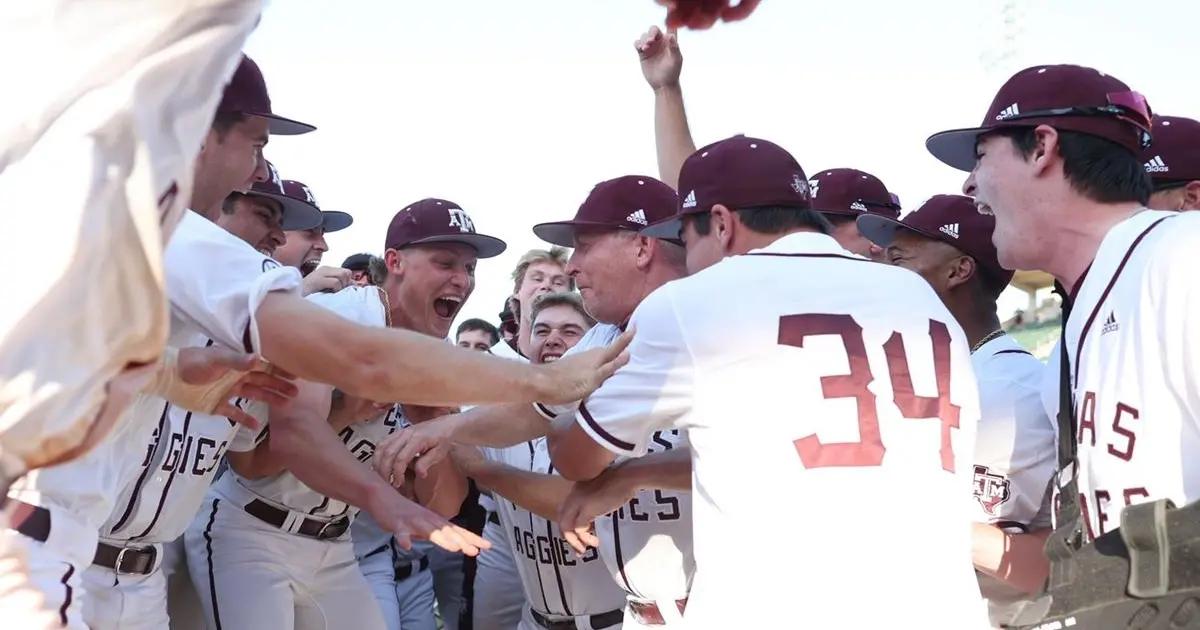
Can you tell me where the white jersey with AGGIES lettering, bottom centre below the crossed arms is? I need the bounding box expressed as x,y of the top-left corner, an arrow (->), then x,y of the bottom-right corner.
485,438 -> 625,617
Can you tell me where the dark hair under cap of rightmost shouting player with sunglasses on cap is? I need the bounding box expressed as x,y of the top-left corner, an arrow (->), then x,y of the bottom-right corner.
995,127 -> 1153,205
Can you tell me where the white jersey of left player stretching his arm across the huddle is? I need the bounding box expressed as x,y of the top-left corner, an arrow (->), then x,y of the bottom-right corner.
10,212 -> 301,535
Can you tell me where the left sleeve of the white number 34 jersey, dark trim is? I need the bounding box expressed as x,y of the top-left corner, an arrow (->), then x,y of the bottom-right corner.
576,286 -> 696,457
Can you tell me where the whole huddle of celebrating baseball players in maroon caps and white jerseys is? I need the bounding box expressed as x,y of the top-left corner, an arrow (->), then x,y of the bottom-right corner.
0,0 -> 1200,630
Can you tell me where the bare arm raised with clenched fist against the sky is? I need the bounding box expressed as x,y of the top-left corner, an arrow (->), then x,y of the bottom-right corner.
634,26 -> 696,188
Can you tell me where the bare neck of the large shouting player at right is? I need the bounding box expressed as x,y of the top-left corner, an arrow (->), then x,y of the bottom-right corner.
1034,196 -> 1141,293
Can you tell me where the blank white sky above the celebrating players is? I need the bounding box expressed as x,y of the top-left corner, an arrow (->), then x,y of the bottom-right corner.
246,0 -> 1200,322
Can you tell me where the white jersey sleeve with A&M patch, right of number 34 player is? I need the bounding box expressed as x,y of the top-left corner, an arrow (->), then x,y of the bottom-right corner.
972,356 -> 1057,532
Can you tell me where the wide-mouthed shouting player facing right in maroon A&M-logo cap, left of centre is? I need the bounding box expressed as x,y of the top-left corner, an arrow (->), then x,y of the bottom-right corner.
186,199 -> 505,628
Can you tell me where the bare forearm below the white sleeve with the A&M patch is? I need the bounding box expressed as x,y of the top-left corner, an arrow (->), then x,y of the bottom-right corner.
971,523 -> 1050,594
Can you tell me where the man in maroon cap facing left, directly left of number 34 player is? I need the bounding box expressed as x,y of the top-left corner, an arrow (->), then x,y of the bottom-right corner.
379,175 -> 692,626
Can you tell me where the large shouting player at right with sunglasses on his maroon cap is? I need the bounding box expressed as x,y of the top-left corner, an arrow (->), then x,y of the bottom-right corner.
926,65 -> 1200,628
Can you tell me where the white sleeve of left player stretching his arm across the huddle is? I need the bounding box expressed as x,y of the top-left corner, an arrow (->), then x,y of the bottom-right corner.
163,211 -> 301,352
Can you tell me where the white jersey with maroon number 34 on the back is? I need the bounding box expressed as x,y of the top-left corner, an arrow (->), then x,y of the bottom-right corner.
577,233 -> 986,628
